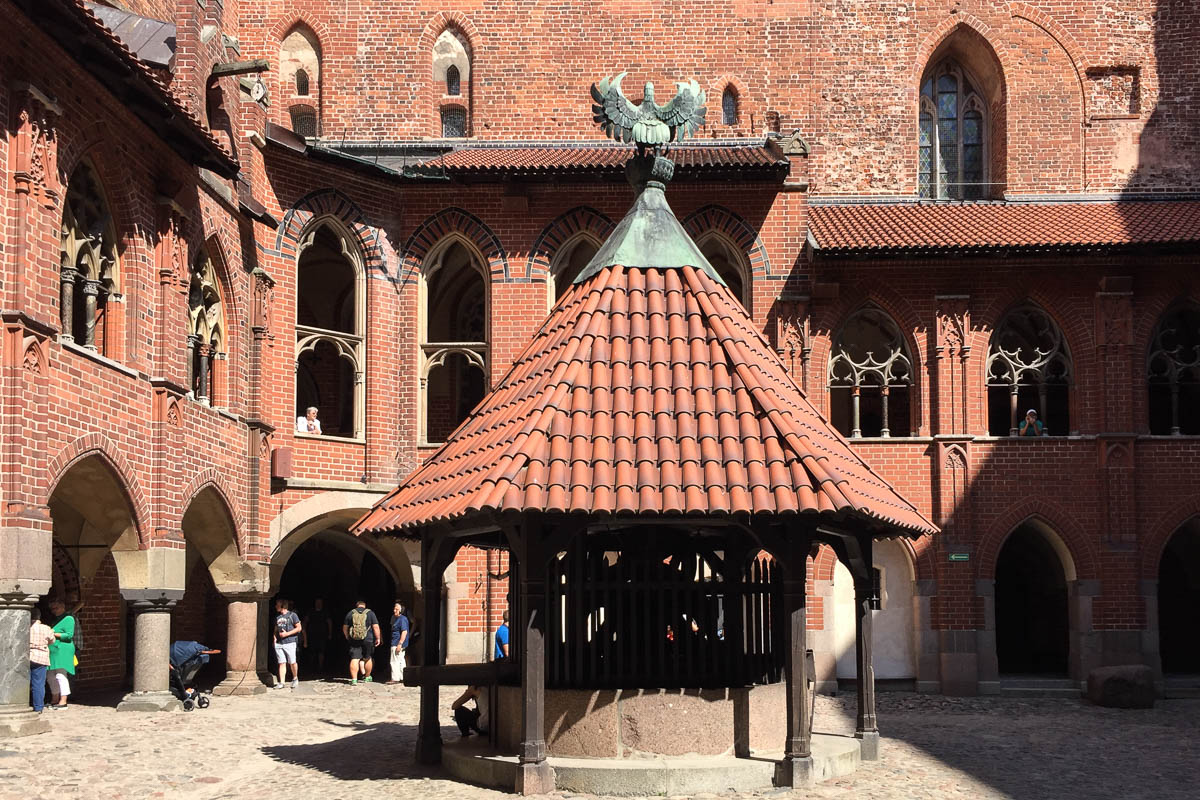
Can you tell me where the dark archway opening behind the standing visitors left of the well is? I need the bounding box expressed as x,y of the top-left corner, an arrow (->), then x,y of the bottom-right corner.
271,530 -> 396,680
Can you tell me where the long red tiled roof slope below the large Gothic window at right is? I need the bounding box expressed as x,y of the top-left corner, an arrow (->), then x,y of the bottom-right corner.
809,200 -> 1200,254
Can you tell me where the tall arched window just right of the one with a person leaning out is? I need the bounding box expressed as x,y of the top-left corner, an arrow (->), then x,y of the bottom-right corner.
421,237 -> 488,444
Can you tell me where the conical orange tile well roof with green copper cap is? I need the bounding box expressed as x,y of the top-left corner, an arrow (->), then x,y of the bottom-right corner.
355,158 -> 937,535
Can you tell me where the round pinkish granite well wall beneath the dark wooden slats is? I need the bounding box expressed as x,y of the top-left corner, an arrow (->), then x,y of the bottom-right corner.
491,684 -> 786,758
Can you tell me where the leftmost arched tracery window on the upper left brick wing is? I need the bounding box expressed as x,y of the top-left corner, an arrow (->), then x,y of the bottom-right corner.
60,162 -> 116,356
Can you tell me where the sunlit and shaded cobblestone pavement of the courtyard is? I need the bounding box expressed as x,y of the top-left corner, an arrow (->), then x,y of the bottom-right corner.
0,682 -> 1200,800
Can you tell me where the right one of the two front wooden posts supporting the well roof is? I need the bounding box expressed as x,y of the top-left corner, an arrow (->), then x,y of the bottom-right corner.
775,530 -> 812,788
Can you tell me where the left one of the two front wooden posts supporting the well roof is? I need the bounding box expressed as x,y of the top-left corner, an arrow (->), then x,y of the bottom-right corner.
514,521 -> 554,795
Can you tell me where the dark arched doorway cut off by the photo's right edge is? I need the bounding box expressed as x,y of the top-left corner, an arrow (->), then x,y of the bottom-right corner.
1158,519 -> 1200,674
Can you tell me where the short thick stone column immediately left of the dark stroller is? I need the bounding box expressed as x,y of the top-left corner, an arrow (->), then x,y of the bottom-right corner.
116,589 -> 184,711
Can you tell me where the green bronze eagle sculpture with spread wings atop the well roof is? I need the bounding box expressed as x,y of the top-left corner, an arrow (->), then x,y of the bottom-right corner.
592,72 -> 708,151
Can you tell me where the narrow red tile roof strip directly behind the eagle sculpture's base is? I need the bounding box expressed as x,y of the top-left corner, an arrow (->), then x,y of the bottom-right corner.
426,143 -> 787,173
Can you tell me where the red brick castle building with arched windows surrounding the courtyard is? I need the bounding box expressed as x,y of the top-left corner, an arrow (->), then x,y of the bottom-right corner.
0,0 -> 1200,728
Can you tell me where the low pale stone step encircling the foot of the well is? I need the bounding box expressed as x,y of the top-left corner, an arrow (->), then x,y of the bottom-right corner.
442,734 -> 859,796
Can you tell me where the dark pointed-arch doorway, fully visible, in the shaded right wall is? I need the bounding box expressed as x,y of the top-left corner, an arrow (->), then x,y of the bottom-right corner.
996,524 -> 1070,675
